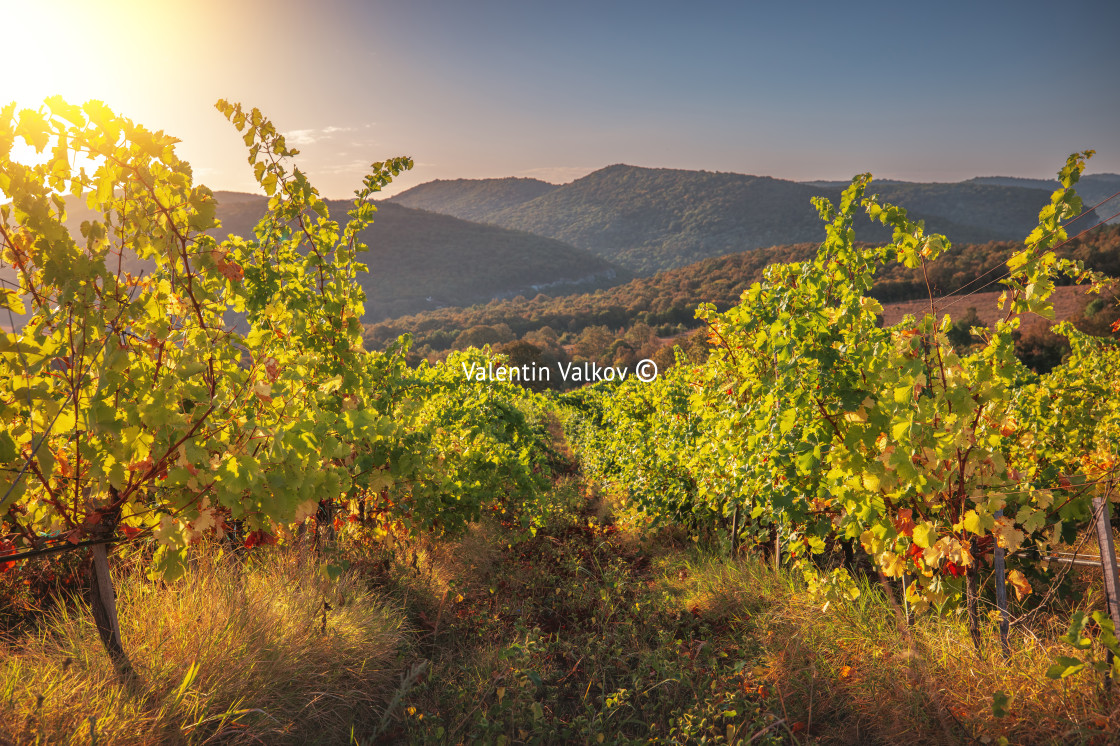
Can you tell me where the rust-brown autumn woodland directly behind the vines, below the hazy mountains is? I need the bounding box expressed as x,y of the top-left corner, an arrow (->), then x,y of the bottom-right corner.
364,219 -> 1120,371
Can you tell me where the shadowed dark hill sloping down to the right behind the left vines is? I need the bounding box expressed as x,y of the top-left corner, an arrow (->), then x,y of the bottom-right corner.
215,192 -> 629,323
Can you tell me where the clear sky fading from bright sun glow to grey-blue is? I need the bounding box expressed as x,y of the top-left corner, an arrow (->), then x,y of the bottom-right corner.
0,0 -> 1120,198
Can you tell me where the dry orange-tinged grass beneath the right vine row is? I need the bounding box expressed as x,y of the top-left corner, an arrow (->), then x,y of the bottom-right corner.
663,558 -> 1120,744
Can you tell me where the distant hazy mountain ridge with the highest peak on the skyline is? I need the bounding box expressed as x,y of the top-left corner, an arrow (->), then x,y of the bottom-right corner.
391,164 -> 1102,274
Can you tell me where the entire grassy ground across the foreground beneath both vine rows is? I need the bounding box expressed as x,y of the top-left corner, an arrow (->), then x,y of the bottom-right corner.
0,472 -> 1120,745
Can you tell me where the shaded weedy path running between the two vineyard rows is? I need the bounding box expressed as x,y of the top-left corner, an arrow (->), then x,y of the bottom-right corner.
371,479 -> 783,744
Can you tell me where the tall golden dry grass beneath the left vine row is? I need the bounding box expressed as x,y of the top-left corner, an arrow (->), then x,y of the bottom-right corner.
0,539 -> 402,744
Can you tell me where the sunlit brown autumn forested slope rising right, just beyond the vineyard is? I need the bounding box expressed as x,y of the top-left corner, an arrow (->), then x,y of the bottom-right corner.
365,225 -> 1120,354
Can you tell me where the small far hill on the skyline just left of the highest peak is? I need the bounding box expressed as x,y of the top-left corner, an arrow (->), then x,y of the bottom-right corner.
390,177 -> 559,223
